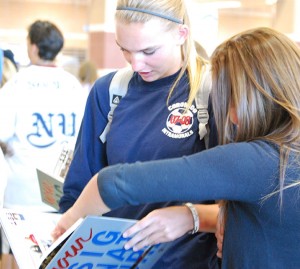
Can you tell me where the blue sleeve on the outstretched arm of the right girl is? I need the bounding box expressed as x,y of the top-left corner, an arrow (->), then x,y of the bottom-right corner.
98,142 -> 278,209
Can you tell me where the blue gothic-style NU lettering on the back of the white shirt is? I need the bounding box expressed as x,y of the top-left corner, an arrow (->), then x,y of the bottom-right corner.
27,113 -> 76,148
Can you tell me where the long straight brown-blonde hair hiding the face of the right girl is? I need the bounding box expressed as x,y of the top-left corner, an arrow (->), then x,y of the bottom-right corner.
211,27 -> 300,203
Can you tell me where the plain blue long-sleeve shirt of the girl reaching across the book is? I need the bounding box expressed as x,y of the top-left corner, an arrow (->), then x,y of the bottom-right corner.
98,141 -> 300,269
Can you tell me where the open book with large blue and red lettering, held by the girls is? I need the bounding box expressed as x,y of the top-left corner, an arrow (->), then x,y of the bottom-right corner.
0,209 -> 169,269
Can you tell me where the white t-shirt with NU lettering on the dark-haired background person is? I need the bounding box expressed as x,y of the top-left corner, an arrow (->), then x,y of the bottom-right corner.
0,65 -> 87,211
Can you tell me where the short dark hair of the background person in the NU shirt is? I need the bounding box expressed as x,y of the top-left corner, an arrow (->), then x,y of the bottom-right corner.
28,20 -> 64,61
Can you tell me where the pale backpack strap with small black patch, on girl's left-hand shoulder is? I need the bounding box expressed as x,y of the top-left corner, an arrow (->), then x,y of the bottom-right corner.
100,67 -> 133,143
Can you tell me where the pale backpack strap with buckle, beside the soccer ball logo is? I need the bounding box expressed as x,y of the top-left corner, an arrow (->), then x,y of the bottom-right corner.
195,65 -> 212,147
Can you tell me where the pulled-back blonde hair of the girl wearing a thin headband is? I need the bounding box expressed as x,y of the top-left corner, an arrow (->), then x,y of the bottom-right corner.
115,0 -> 206,107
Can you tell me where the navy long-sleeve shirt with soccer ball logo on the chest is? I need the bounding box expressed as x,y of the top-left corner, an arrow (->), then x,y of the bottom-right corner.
60,70 -> 218,269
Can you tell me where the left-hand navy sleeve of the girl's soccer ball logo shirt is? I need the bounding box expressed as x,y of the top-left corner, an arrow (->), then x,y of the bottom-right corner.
59,74 -> 112,212
